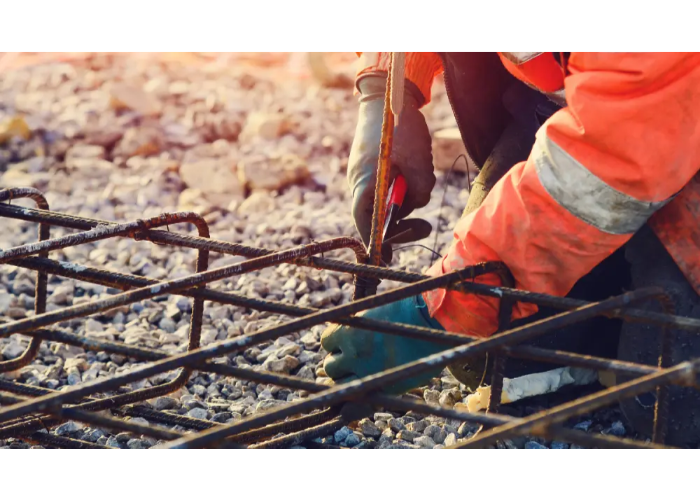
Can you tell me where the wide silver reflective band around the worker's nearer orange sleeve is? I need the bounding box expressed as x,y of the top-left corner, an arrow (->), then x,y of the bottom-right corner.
533,132 -> 673,234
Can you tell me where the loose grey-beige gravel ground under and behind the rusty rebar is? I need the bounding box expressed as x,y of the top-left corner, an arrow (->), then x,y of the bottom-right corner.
0,53 -> 644,449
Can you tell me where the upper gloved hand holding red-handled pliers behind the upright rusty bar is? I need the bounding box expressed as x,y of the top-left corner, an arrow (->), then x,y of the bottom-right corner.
348,75 -> 435,245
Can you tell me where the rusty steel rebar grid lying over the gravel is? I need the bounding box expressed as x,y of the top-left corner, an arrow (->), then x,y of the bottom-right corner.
0,188 -> 700,449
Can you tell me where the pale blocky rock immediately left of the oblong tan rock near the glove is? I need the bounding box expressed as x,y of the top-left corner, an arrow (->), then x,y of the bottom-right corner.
180,158 -> 245,208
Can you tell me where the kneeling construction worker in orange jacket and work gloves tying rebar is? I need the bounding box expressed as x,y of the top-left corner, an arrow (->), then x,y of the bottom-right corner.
322,51 -> 700,445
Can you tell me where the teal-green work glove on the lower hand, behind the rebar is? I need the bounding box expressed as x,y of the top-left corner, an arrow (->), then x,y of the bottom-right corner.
321,296 -> 449,394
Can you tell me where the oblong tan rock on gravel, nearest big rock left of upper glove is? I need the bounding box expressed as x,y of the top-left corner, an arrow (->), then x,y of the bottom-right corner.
238,154 -> 311,191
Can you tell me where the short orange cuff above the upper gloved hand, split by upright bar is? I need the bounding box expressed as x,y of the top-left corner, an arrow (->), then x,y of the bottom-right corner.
356,51 -> 442,104
